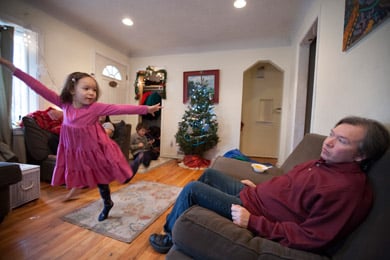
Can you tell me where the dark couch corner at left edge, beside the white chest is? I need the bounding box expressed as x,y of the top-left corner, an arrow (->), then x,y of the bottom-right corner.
0,162 -> 22,223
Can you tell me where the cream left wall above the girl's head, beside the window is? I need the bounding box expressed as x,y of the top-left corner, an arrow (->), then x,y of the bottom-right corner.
0,0 -> 134,117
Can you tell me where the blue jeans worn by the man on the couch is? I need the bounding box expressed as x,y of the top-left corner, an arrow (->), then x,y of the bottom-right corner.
164,169 -> 245,235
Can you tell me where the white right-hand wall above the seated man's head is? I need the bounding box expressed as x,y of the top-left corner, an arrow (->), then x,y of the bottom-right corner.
295,0 -> 390,138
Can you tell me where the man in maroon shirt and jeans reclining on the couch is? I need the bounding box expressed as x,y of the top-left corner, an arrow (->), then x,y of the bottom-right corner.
149,117 -> 390,253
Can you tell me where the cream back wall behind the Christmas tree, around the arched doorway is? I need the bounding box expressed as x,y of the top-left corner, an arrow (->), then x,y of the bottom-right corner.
130,48 -> 293,159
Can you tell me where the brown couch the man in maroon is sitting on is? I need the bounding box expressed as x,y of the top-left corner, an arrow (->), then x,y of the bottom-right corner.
166,134 -> 390,260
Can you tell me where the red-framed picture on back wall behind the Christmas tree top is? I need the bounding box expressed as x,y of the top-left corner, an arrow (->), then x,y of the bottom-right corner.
183,70 -> 219,103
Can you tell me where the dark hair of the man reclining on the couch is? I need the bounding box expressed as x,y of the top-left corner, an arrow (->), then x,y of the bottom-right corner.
336,116 -> 390,171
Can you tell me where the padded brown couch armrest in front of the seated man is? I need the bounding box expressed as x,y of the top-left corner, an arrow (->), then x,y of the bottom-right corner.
172,206 -> 328,260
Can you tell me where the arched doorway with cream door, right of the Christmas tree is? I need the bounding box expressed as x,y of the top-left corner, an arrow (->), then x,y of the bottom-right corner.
240,61 -> 283,158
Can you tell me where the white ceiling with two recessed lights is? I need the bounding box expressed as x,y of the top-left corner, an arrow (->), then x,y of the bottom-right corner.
25,0 -> 312,57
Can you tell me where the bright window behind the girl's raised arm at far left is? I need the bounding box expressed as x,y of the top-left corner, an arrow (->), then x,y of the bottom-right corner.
11,25 -> 39,122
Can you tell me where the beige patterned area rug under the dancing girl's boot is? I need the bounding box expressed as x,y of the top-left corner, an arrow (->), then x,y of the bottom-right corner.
62,181 -> 182,243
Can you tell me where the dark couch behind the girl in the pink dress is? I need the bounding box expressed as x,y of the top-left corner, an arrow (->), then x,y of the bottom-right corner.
22,116 -> 131,183
